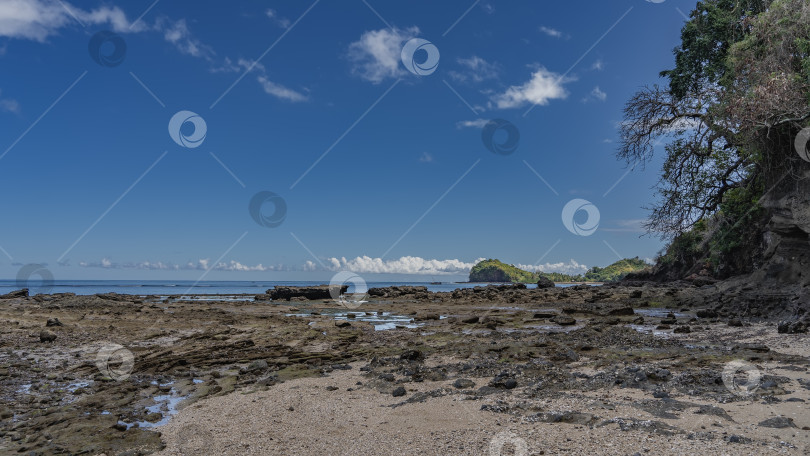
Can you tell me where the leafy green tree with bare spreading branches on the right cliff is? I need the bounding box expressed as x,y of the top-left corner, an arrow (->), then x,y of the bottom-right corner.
617,0 -> 810,278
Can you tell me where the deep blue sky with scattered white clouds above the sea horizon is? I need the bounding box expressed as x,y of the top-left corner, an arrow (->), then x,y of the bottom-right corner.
0,0 -> 694,280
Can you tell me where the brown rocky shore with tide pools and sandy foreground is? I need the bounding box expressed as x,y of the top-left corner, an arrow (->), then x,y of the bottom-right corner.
0,282 -> 810,455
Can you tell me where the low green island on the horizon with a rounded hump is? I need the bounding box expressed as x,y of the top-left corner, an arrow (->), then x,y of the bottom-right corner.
469,257 -> 649,283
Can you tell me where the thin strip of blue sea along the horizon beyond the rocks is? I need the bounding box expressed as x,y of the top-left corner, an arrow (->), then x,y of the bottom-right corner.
0,280 -> 592,296
